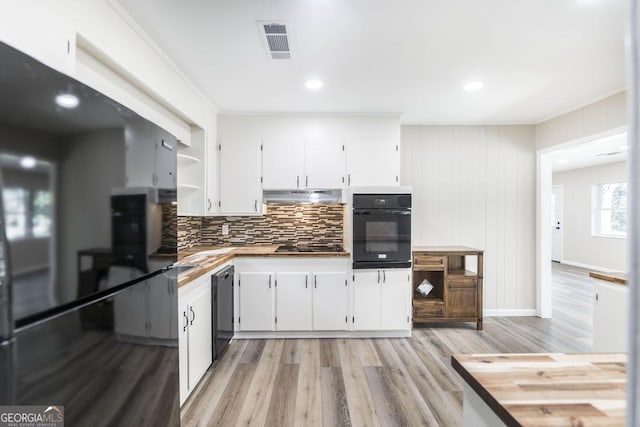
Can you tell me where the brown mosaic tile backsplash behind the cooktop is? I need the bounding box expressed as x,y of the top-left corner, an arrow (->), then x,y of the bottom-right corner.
178,204 -> 345,249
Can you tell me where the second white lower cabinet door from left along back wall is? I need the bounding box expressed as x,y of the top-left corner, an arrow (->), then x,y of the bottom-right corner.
276,272 -> 311,331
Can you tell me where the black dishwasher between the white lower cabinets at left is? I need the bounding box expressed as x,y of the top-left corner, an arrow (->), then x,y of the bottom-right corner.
211,266 -> 234,360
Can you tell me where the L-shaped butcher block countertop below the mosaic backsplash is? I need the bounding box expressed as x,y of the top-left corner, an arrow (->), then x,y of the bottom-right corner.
176,245 -> 349,287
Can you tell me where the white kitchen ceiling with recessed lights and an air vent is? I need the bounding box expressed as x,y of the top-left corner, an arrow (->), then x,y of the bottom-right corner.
118,0 -> 627,124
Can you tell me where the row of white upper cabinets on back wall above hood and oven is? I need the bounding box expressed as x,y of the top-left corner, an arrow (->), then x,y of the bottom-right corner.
218,115 -> 400,204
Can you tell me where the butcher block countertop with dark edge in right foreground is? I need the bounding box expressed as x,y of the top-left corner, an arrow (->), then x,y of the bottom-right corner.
451,353 -> 627,426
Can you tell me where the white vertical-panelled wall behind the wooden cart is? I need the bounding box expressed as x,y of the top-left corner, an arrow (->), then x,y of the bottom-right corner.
400,126 -> 536,314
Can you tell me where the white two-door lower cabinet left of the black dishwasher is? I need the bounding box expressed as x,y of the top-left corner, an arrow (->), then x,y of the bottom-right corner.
178,274 -> 212,405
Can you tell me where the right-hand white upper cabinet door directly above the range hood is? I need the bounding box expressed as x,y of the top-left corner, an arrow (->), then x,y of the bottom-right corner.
304,138 -> 345,189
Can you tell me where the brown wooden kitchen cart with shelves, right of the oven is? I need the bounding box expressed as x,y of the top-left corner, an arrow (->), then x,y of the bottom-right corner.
413,246 -> 484,330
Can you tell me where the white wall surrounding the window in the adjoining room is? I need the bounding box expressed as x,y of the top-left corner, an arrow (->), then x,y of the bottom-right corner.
553,162 -> 627,271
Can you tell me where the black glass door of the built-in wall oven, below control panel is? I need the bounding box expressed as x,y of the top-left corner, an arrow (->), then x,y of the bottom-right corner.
353,209 -> 411,268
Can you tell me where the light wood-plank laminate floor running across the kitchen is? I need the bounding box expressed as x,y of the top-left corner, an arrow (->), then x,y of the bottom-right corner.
182,266 -> 593,427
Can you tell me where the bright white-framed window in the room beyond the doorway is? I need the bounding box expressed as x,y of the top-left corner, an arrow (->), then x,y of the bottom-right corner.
592,182 -> 627,237
